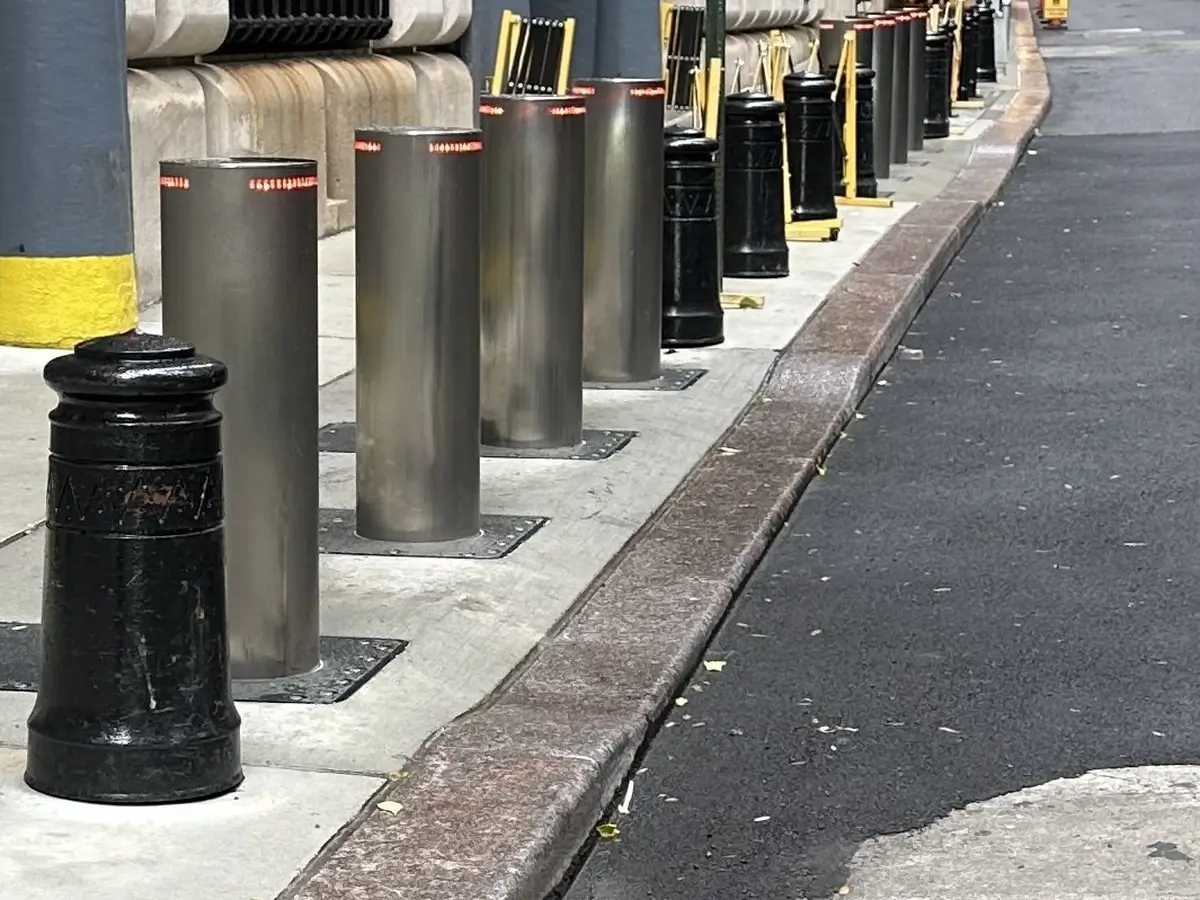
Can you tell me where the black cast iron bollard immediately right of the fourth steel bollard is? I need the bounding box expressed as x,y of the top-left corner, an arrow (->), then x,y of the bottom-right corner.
662,127 -> 725,348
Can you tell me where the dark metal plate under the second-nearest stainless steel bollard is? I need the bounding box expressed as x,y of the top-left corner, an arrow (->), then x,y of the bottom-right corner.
318,509 -> 550,559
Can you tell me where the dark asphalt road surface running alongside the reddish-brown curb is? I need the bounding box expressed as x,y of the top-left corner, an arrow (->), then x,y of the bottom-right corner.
560,0 -> 1200,900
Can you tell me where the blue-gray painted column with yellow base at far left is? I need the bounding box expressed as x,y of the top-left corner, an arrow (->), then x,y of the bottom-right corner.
0,0 -> 136,347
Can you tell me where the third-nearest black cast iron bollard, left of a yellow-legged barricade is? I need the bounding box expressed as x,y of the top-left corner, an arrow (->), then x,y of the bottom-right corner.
724,91 -> 787,278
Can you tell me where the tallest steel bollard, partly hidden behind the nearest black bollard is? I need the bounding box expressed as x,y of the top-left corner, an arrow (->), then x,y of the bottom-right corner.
160,158 -> 320,678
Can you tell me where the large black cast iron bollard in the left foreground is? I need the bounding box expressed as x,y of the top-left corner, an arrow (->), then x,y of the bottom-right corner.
25,332 -> 242,804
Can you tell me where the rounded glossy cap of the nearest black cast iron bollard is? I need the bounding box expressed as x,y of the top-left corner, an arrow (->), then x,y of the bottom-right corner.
42,331 -> 229,400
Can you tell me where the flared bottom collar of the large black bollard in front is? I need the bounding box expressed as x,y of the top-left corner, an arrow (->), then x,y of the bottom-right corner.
25,728 -> 245,806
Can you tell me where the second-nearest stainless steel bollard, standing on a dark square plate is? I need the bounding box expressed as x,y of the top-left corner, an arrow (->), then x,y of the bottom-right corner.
354,127 -> 484,542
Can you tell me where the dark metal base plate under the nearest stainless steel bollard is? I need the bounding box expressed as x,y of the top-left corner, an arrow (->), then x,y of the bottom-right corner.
0,622 -> 408,706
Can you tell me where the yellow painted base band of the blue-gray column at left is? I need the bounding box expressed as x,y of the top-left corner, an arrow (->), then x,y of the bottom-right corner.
0,253 -> 138,349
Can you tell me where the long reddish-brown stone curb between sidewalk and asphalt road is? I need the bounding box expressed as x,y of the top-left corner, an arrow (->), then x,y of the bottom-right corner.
283,0 -> 1050,900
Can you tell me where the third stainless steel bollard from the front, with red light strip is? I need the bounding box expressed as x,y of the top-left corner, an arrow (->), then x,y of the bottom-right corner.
480,95 -> 588,449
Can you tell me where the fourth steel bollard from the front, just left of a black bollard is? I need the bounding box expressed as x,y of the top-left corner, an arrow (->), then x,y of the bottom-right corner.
572,78 -> 666,382
